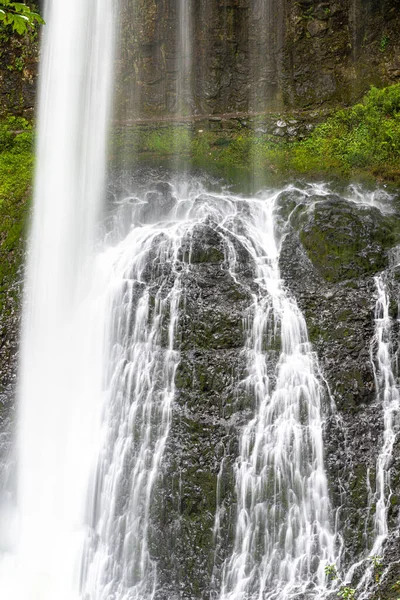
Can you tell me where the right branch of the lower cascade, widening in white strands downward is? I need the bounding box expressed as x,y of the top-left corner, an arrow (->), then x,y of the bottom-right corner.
221,189 -> 335,600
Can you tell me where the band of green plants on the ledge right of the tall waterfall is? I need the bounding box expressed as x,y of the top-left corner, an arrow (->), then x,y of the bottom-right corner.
114,84 -> 400,181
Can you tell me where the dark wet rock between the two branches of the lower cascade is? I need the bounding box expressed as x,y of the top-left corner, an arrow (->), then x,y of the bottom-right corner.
147,224 -> 254,598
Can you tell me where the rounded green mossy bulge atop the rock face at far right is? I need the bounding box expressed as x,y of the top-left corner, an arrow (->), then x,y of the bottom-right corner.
297,196 -> 400,283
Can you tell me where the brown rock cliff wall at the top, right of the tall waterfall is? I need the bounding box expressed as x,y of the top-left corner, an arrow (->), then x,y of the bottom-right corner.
113,0 -> 400,119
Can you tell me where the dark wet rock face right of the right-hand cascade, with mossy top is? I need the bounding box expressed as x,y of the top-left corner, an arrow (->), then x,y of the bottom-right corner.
280,191 -> 400,576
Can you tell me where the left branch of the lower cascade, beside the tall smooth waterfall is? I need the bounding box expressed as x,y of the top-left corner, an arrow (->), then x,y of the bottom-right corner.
83,192 -> 181,600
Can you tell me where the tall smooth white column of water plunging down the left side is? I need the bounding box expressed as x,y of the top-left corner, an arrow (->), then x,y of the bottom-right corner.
0,0 -> 114,600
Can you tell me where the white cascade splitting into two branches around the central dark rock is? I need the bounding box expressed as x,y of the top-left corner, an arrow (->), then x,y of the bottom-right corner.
71,181 -> 334,600
